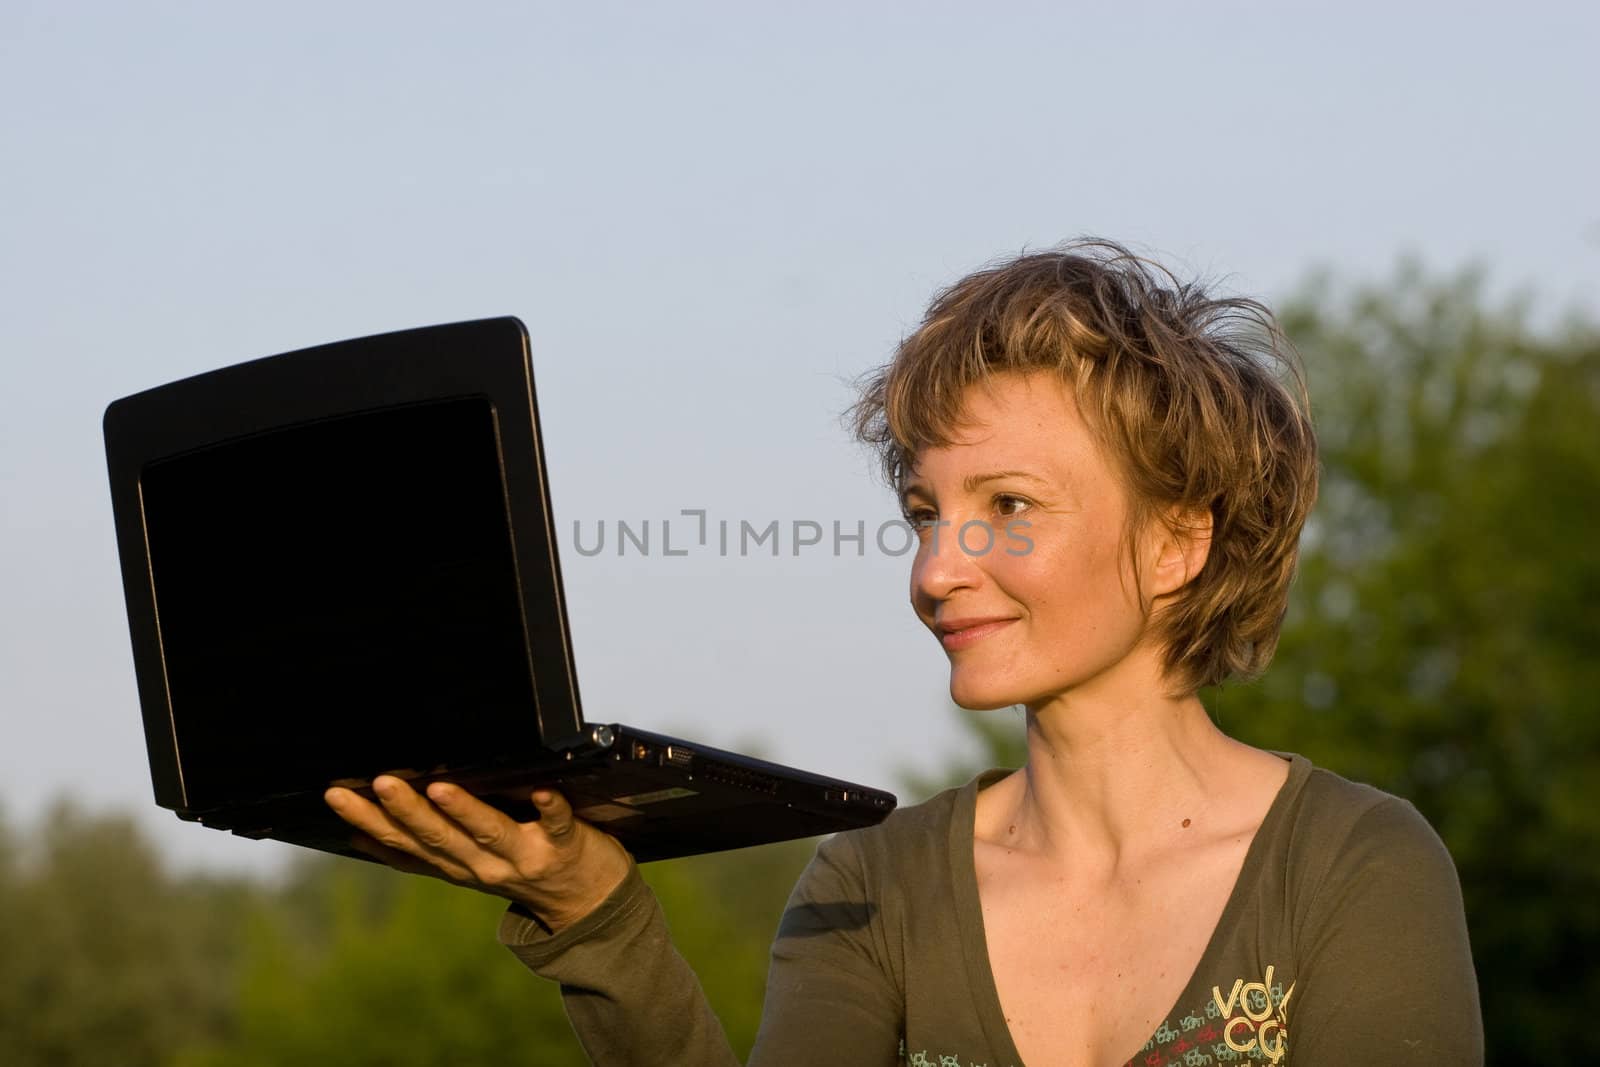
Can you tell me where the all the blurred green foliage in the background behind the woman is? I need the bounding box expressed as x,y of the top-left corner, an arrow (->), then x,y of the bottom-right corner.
0,260 -> 1600,1067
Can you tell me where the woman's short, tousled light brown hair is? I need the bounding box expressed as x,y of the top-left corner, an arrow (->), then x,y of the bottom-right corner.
850,238 -> 1317,693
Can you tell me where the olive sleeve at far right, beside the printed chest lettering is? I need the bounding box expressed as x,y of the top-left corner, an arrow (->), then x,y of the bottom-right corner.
1283,797 -> 1483,1067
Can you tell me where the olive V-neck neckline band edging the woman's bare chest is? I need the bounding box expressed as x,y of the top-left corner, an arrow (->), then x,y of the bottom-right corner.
950,749 -> 1310,1067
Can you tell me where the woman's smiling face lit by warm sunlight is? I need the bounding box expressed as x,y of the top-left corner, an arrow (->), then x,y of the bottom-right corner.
904,373 -> 1154,709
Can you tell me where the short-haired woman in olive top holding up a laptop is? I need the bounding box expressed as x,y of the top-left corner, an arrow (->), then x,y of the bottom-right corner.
328,242 -> 1483,1067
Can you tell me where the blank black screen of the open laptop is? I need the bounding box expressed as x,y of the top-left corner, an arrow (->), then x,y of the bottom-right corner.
141,397 -> 539,809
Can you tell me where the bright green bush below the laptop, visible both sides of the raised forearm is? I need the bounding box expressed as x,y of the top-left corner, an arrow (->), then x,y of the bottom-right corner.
174,841 -> 811,1067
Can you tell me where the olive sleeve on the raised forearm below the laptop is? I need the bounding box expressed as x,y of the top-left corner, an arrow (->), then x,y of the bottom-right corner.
499,865 -> 739,1067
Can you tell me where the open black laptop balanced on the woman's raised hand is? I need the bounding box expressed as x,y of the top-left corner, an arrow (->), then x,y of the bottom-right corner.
106,318 -> 894,861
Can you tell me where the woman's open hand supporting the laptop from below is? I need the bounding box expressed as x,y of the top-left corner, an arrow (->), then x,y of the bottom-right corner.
323,774 -> 629,931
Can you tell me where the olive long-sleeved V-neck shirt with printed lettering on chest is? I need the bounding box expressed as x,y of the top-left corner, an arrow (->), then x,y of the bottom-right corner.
499,753 -> 1483,1067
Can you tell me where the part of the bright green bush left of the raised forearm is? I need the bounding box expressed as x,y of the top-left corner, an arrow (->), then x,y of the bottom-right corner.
173,857 -> 587,1067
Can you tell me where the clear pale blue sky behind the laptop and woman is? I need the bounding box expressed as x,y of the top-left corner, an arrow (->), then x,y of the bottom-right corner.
0,0 -> 1600,867
